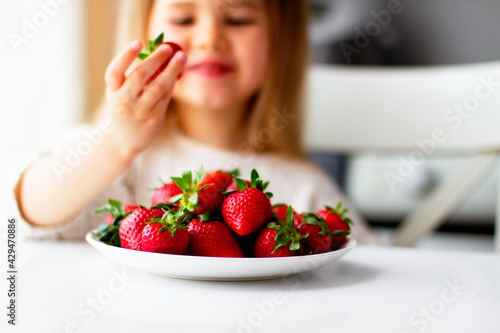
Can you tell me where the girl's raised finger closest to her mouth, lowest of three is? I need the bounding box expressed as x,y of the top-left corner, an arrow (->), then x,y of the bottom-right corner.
141,51 -> 186,107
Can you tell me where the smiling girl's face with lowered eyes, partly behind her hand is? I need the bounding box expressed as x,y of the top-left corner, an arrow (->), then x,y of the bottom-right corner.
148,0 -> 269,110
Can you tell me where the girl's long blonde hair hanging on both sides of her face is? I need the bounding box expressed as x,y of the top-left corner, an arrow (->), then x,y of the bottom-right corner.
90,0 -> 309,160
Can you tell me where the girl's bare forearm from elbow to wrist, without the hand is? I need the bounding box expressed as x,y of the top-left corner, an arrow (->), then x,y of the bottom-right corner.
15,132 -> 133,226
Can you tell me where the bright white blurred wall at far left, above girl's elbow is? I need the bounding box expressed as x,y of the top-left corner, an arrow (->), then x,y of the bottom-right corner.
0,0 -> 86,171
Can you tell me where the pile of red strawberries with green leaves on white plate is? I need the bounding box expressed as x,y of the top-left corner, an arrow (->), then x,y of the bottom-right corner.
95,166 -> 352,257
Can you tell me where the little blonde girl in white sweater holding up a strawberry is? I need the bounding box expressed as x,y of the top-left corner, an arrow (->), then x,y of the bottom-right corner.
5,0 -> 373,242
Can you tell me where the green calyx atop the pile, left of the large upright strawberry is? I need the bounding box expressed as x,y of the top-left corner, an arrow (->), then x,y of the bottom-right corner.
168,165 -> 207,212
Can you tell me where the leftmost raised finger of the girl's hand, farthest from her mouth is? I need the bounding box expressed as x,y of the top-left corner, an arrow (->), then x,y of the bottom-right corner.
105,41 -> 142,91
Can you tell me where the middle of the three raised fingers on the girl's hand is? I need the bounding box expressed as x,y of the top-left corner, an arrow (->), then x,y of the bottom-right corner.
125,45 -> 173,98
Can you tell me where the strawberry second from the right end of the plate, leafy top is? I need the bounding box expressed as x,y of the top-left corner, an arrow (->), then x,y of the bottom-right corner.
294,213 -> 331,254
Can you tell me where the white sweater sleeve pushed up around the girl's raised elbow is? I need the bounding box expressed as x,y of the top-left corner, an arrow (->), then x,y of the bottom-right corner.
0,125 -> 134,240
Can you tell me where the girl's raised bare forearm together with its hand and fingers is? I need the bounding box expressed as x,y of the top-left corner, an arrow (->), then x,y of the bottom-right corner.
15,42 -> 186,226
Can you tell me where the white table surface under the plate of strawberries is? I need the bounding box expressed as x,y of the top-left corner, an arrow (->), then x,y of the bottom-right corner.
0,242 -> 500,333
